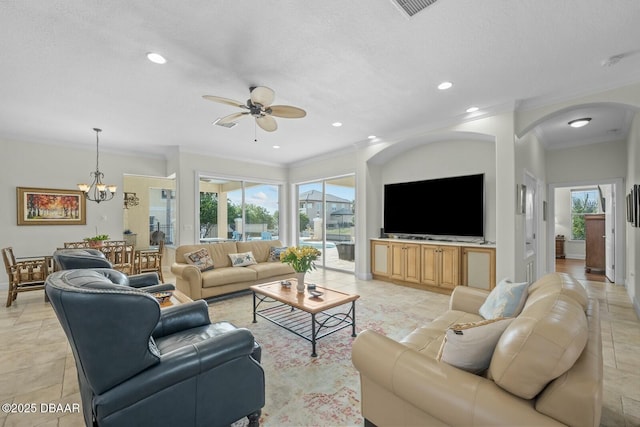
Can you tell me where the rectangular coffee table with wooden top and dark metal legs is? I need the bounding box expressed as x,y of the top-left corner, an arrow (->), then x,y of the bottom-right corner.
250,279 -> 360,357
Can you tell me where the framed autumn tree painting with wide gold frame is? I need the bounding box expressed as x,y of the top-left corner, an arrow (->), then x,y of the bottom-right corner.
16,187 -> 87,225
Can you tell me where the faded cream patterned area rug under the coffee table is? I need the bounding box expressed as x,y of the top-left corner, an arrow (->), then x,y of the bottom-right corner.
209,282 -> 448,427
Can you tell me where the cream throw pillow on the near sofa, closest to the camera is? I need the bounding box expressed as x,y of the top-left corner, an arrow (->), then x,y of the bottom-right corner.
437,317 -> 513,374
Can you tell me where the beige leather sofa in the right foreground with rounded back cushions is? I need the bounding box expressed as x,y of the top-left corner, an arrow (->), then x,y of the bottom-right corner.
352,273 -> 603,427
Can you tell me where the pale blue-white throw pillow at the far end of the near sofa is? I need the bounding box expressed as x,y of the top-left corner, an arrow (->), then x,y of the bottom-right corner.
479,279 -> 529,319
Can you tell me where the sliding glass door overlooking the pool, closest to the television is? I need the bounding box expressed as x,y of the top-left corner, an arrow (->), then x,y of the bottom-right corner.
298,175 -> 355,272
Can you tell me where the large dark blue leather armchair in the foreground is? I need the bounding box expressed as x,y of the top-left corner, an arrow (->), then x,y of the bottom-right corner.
45,269 -> 265,427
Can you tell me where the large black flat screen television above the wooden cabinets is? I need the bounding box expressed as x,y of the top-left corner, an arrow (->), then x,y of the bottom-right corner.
383,174 -> 485,239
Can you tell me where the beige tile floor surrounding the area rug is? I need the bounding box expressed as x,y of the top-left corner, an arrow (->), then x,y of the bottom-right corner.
0,272 -> 640,427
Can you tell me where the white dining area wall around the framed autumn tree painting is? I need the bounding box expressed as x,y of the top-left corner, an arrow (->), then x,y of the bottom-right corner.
0,139 -> 166,256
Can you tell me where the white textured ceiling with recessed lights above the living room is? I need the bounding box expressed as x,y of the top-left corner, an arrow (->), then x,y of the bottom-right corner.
0,0 -> 640,165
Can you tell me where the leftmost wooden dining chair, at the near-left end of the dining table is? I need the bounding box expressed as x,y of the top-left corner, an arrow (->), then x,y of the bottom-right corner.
2,247 -> 52,307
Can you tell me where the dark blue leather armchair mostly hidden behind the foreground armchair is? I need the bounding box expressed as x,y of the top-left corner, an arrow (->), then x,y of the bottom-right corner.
53,249 -> 176,292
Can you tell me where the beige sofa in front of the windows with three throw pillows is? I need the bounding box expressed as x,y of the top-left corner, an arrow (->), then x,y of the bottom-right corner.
171,240 -> 295,300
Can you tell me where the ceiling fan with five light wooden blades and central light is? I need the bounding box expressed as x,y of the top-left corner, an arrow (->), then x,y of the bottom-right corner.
202,86 -> 307,132
